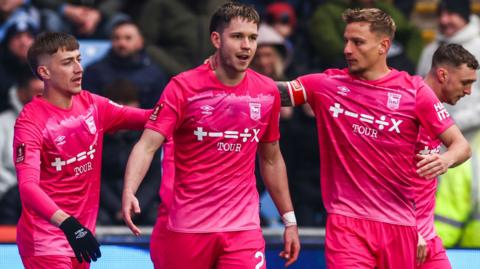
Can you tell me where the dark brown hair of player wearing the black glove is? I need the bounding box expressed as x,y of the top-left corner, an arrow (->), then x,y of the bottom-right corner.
27,32 -> 80,79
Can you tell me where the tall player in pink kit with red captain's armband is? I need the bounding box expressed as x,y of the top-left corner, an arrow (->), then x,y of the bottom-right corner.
279,9 -> 470,269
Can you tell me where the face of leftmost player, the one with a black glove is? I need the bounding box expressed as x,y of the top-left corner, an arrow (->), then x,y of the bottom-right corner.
40,48 -> 83,95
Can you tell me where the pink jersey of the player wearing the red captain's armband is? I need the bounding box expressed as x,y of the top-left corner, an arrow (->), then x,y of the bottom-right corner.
289,69 -> 450,226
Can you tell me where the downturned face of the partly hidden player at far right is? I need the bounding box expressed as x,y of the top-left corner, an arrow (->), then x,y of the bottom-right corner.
442,64 -> 477,105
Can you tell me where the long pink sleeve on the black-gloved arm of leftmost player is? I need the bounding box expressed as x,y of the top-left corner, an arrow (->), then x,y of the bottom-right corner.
13,119 -> 59,221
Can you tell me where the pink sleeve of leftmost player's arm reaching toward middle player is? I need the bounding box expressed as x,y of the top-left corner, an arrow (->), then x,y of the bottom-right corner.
92,94 -> 153,132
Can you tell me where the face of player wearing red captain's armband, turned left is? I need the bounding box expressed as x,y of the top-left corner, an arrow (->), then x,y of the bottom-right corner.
343,22 -> 386,75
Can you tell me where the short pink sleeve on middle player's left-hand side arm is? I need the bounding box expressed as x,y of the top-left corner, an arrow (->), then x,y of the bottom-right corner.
145,79 -> 184,137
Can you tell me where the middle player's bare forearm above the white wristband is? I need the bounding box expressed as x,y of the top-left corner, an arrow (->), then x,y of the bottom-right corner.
260,150 -> 293,215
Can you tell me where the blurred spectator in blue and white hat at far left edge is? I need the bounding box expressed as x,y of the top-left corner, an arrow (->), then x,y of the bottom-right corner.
0,14 -> 38,111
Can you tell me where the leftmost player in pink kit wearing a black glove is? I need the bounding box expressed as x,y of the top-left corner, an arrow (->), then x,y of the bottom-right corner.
14,33 -> 151,269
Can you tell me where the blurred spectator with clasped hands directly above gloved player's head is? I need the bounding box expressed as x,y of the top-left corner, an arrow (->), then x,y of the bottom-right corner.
32,0 -> 128,38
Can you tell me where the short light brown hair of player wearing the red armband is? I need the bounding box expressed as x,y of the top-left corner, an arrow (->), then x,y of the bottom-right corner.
342,8 -> 397,40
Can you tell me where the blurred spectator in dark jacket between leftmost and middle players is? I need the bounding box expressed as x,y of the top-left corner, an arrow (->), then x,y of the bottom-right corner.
83,20 -> 166,108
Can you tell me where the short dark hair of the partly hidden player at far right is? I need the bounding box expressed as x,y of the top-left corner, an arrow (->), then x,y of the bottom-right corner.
432,44 -> 478,70
